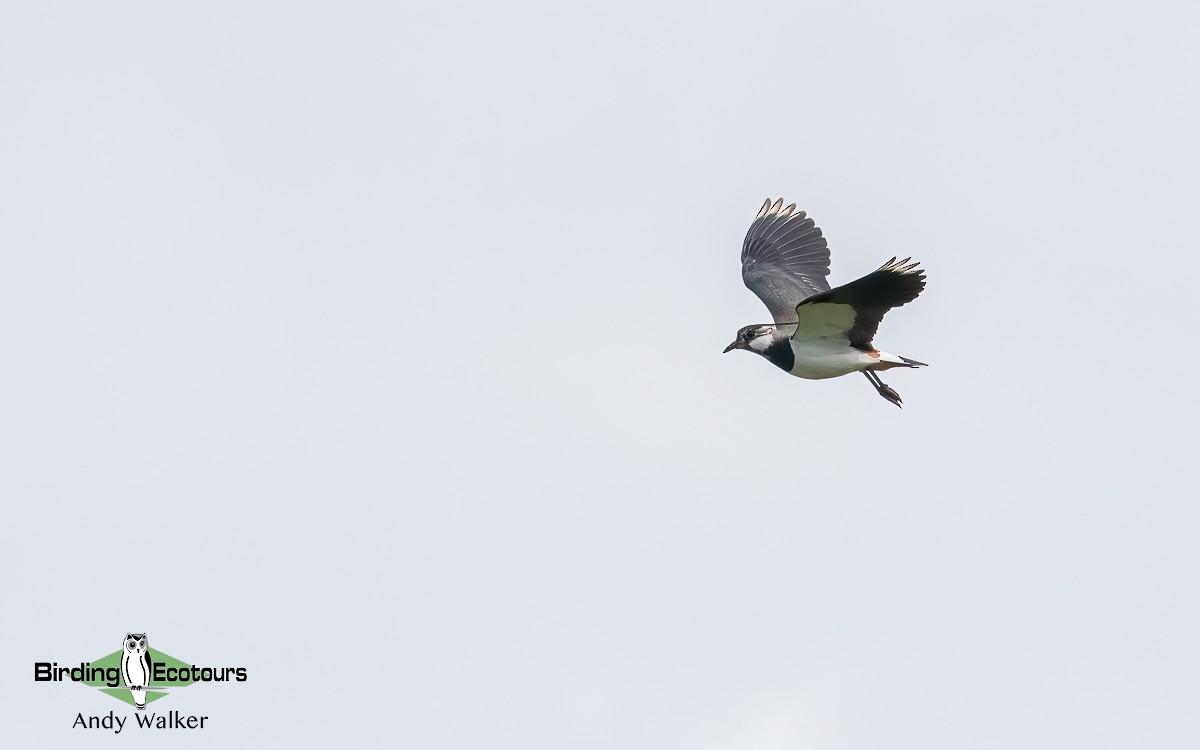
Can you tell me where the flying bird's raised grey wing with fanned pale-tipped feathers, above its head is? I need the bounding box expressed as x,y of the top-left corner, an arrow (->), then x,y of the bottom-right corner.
742,199 -> 829,323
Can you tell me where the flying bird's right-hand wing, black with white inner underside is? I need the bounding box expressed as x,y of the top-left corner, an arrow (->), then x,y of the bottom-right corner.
792,258 -> 925,349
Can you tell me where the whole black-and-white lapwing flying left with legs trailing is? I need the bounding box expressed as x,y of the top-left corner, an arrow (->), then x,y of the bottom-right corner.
725,198 -> 928,408
